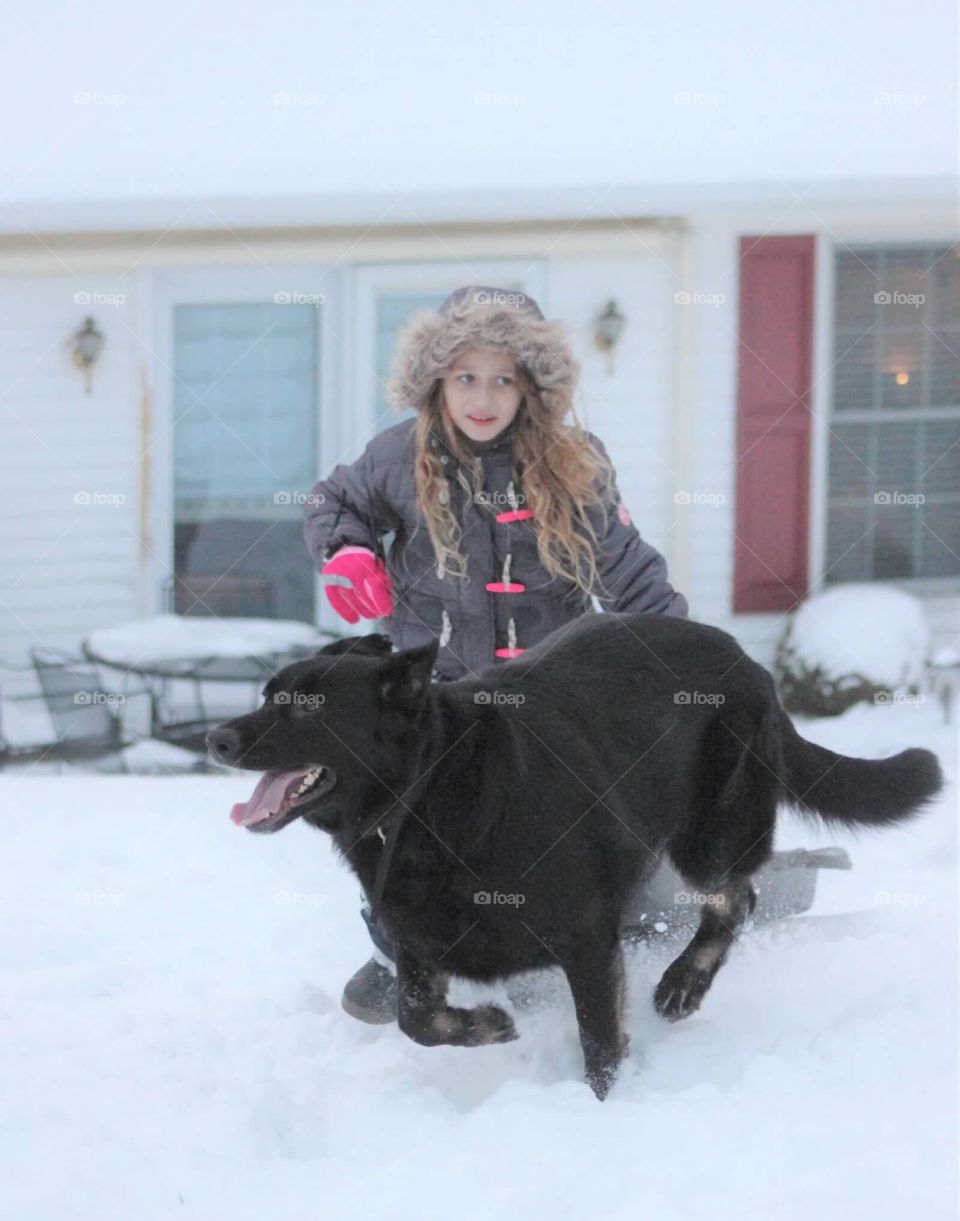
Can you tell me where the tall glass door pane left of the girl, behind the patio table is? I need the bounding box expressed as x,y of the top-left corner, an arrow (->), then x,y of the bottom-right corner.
171,303 -> 318,623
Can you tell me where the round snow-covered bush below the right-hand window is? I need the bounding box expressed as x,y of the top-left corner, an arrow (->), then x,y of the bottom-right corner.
773,582 -> 929,717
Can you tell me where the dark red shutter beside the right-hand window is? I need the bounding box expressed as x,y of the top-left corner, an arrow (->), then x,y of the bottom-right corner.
733,237 -> 815,612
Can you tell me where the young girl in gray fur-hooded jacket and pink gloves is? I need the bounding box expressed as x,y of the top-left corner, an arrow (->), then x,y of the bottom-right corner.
304,286 -> 688,1022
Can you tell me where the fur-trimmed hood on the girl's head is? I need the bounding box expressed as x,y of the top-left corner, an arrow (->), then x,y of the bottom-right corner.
387,284 -> 580,420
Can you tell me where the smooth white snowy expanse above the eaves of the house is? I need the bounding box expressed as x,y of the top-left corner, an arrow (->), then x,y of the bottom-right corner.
0,0 -> 958,203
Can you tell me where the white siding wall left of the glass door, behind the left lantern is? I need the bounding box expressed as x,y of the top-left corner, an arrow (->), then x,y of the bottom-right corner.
0,274 -> 140,656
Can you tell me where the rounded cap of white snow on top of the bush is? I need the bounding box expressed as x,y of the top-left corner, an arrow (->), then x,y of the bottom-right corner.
776,581 -> 931,690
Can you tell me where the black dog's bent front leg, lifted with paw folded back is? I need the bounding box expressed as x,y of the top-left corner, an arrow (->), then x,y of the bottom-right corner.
397,946 -> 517,1048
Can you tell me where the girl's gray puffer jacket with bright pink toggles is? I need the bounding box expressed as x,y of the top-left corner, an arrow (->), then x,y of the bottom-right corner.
304,419 -> 689,679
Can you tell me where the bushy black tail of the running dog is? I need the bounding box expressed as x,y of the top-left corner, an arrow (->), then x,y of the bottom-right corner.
778,705 -> 944,827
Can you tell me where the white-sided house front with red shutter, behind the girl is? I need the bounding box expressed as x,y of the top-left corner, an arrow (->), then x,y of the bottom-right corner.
0,178 -> 960,663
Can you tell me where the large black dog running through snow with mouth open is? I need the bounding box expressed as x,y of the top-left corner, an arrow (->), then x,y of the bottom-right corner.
208,613 -> 943,1098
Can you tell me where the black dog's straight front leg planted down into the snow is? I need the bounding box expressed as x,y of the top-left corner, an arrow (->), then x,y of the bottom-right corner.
561,937 -> 630,1101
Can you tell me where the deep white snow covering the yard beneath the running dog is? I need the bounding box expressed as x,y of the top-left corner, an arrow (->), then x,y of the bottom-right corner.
0,705 -> 958,1221
